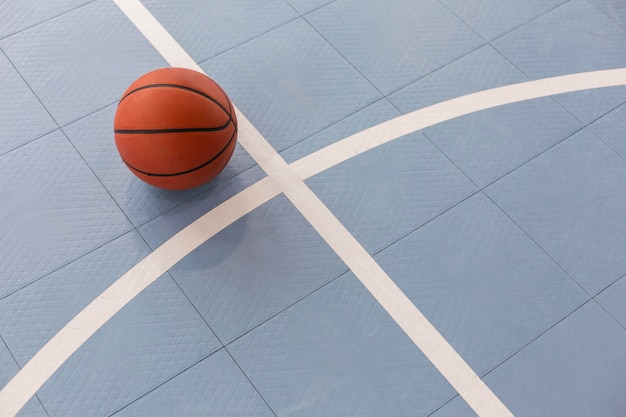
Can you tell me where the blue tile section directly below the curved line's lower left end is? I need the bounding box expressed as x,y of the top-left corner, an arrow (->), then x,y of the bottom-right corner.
38,274 -> 221,417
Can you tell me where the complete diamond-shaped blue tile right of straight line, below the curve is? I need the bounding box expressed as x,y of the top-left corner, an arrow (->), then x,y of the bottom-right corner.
375,193 -> 589,376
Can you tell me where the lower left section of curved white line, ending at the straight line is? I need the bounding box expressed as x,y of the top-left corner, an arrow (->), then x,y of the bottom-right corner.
0,177 -> 280,417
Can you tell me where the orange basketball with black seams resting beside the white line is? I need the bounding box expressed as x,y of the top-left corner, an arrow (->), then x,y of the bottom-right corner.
113,68 -> 237,190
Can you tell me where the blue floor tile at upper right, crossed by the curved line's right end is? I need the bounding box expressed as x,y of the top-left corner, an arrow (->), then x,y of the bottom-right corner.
493,0 -> 626,123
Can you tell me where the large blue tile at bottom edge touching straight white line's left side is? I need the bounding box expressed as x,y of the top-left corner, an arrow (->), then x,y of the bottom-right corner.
228,273 -> 454,417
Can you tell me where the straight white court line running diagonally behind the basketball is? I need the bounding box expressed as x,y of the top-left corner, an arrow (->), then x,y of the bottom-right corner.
109,0 -> 512,417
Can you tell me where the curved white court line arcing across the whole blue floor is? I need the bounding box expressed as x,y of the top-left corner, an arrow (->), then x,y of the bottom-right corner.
0,68 -> 626,417
